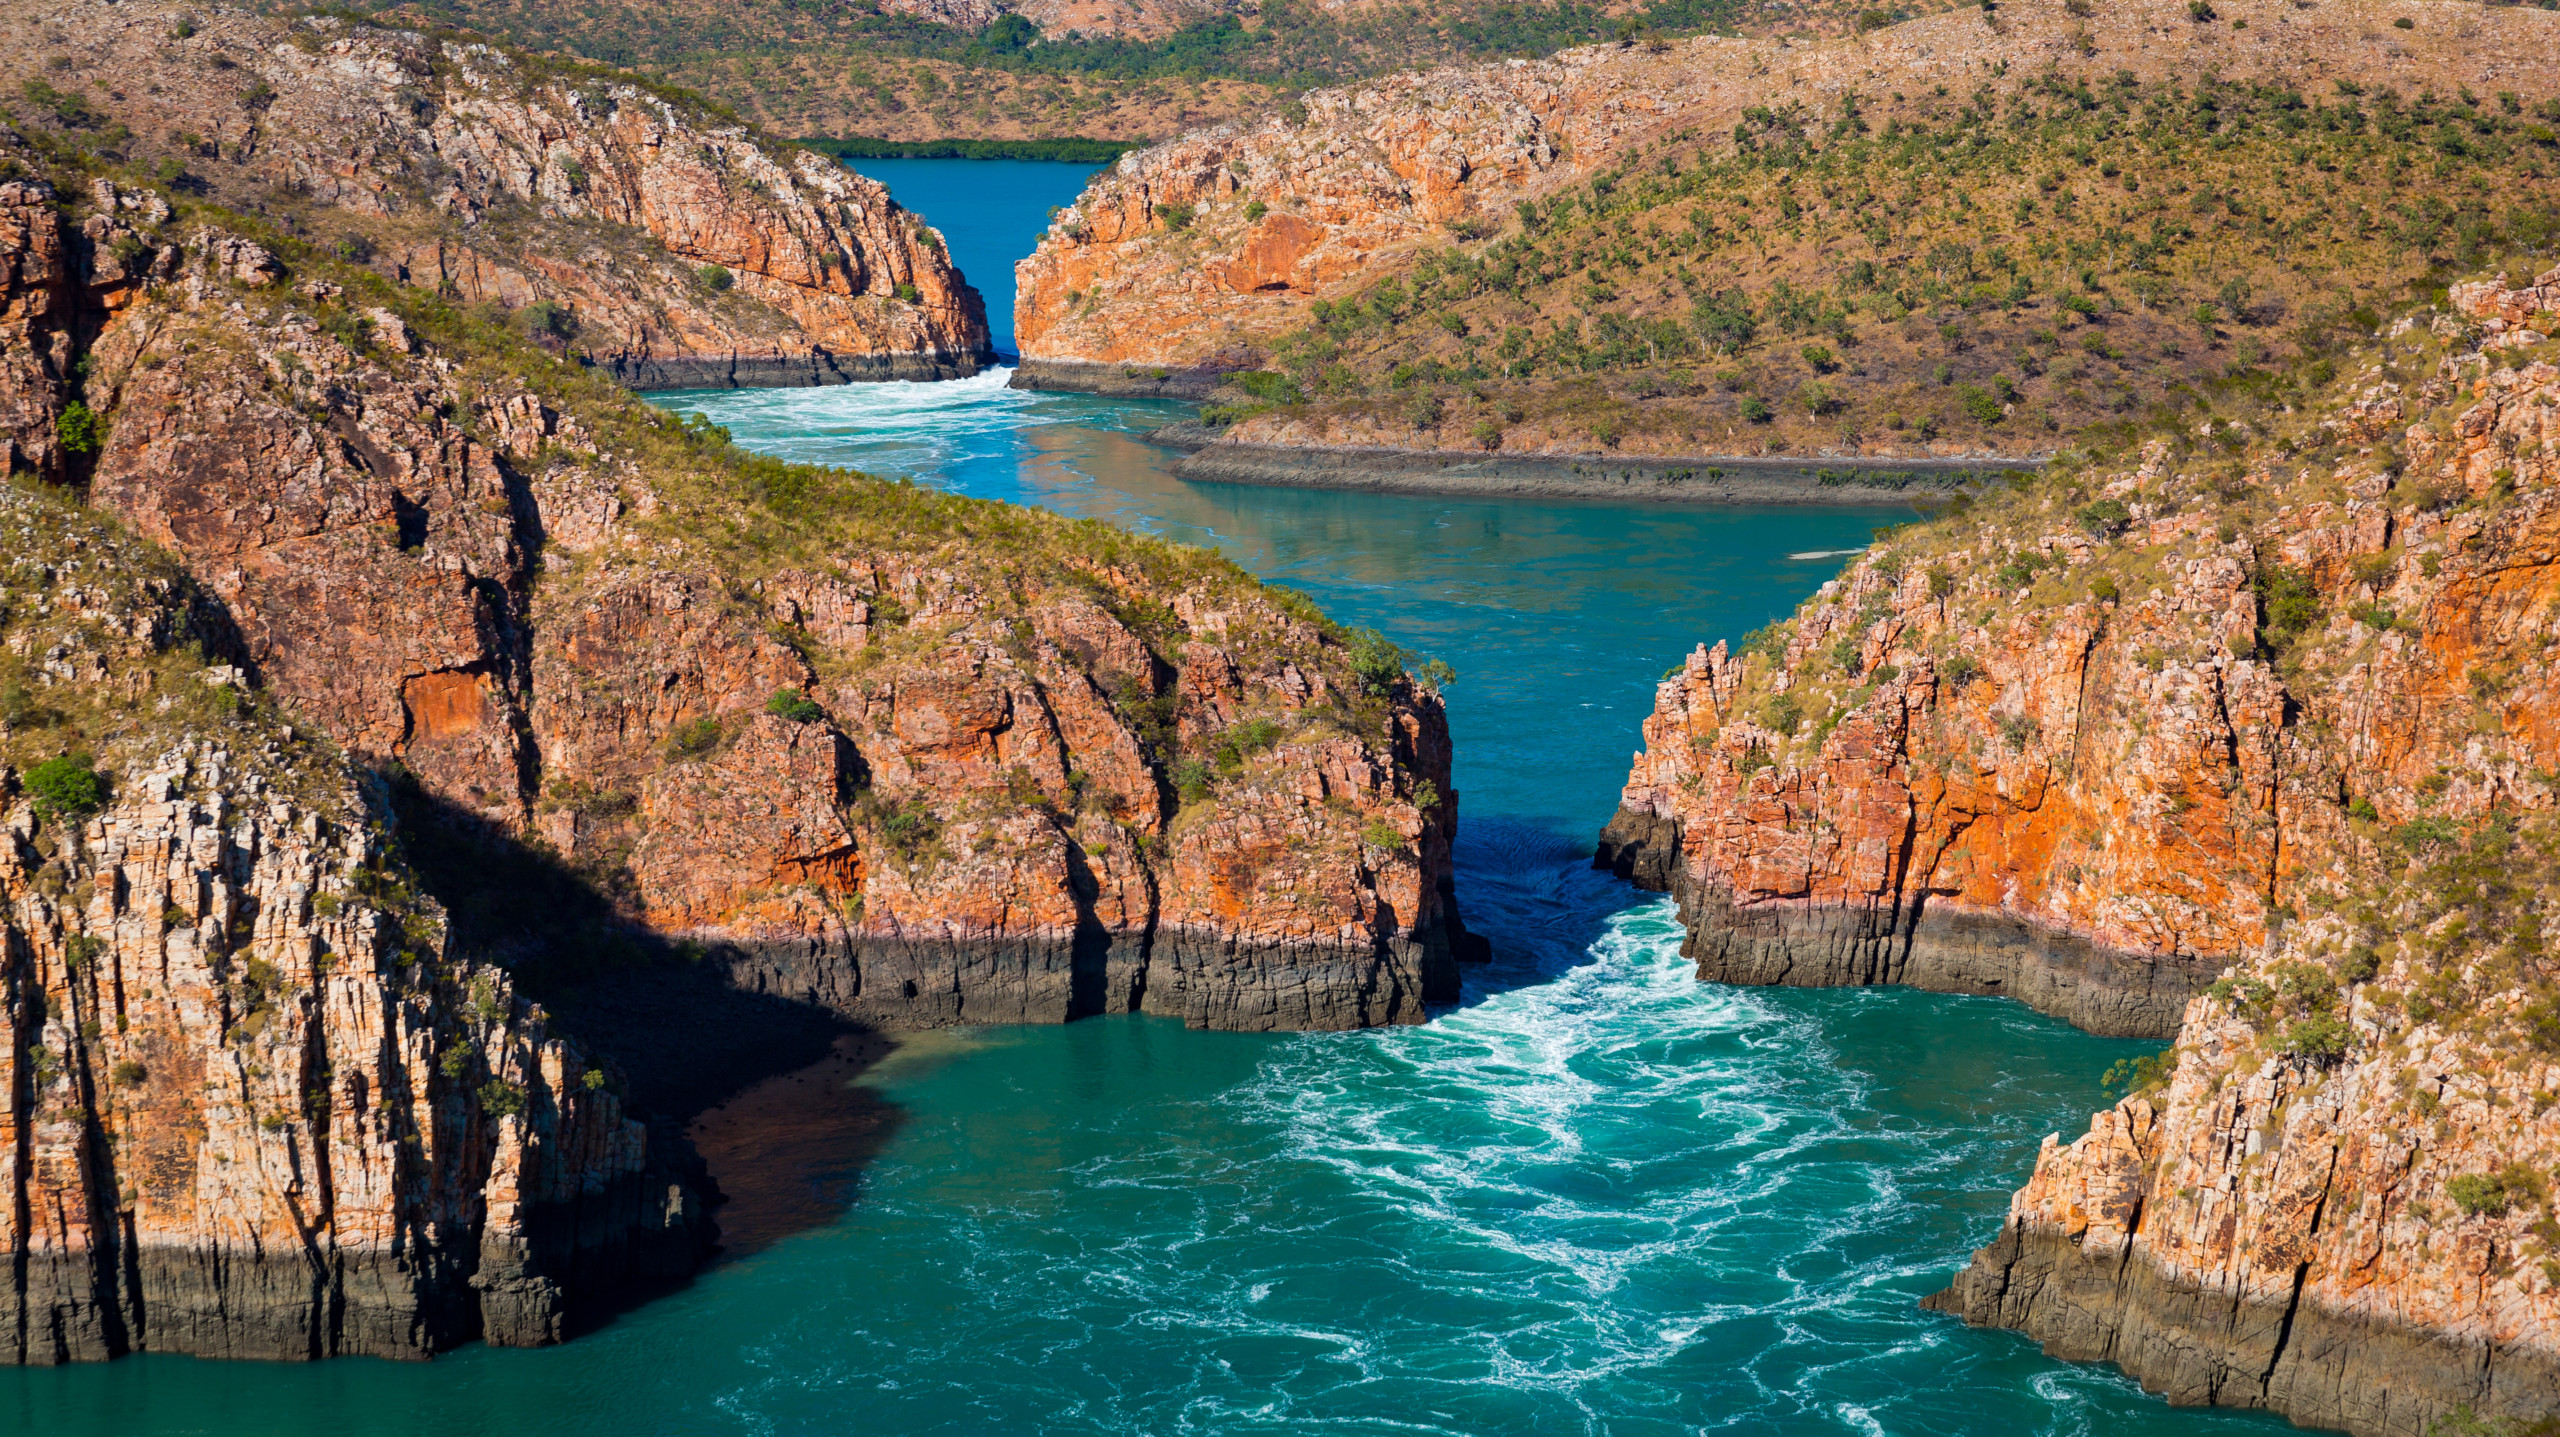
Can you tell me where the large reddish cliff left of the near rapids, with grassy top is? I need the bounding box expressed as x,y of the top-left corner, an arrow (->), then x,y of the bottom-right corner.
0,156 -> 1472,1027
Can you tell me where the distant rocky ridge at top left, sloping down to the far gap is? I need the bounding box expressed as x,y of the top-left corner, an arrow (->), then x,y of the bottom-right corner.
0,3 -> 991,389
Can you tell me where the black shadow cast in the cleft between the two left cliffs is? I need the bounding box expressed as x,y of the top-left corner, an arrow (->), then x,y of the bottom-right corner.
384,768 -> 906,1270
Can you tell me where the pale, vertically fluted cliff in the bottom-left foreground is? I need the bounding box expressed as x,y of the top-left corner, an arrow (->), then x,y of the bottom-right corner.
0,487 -> 709,1363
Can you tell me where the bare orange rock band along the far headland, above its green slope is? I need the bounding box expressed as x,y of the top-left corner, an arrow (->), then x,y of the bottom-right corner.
1014,0 -> 2560,386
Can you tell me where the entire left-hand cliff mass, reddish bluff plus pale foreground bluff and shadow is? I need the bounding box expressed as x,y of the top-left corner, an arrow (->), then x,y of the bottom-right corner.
0,22 -> 1480,1363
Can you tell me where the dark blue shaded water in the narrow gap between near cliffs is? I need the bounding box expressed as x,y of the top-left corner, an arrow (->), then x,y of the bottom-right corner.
1449,815 -> 1659,1007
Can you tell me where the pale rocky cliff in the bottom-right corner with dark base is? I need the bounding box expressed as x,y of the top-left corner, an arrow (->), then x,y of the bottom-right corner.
1928,820 -> 2560,1437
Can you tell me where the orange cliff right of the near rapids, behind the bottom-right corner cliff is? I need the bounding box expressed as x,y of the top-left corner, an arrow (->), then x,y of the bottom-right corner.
1603,277 -> 2560,1035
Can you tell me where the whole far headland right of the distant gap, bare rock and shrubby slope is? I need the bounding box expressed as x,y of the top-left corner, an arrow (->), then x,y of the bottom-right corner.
1016,0 -> 2560,474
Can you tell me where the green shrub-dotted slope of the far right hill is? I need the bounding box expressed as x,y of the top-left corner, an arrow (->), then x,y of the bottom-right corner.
1213,72 -> 2560,453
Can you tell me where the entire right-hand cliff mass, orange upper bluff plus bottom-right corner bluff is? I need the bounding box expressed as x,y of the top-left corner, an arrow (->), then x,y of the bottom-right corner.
1603,269 -> 2560,1434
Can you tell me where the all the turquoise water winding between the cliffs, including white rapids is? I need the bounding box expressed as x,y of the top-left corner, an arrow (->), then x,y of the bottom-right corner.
0,161 -> 2281,1437
